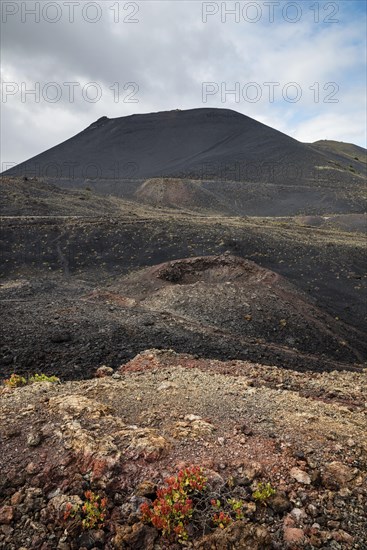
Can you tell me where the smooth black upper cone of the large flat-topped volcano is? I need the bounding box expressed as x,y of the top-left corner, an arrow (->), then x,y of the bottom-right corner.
6,109 -> 366,185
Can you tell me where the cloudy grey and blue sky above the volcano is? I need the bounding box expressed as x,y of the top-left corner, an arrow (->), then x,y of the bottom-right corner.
0,0 -> 366,169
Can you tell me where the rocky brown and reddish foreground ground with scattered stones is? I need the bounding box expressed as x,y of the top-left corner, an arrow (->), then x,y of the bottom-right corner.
0,350 -> 367,550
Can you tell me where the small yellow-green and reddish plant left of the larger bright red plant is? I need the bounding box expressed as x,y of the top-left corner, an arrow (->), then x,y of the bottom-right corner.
64,491 -> 107,531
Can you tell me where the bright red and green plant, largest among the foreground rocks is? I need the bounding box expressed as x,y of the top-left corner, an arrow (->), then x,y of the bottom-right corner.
140,466 -> 207,541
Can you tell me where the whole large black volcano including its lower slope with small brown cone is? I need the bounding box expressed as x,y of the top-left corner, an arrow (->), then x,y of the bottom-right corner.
3,108 -> 367,216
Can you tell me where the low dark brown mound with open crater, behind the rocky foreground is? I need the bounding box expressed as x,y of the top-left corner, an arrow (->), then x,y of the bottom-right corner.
0,256 -> 367,380
